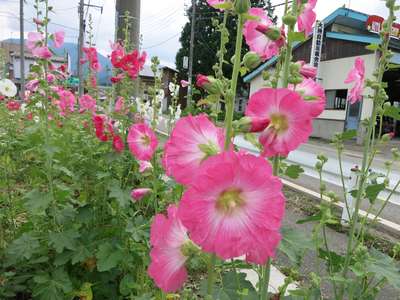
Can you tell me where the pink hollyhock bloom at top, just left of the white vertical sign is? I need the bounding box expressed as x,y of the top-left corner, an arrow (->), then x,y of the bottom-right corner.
243,8 -> 284,60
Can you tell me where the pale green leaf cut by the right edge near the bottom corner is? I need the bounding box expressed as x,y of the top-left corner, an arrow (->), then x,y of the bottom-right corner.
366,248 -> 400,290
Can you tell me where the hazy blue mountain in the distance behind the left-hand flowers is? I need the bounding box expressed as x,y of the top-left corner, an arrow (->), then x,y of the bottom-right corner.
4,39 -> 112,85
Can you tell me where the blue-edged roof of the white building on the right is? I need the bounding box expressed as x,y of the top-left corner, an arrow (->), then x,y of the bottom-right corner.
243,7 -> 400,82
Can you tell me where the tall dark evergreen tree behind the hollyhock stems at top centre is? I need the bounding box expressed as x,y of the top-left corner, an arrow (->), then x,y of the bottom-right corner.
176,0 -> 276,95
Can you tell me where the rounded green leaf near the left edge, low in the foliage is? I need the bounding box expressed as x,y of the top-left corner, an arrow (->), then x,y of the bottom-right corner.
7,232 -> 40,260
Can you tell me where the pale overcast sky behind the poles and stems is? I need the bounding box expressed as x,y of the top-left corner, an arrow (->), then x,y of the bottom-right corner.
0,0 -> 398,65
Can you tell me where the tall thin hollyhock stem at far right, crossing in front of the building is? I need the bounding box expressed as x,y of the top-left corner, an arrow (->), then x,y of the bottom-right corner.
339,3 -> 395,299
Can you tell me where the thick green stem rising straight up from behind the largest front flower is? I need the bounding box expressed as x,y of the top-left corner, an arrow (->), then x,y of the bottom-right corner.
225,15 -> 244,149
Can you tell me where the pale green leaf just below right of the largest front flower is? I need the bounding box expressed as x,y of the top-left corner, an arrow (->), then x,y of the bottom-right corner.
279,227 -> 314,264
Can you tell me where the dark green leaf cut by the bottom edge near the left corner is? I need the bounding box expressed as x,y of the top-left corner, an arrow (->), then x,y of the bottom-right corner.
32,269 -> 72,300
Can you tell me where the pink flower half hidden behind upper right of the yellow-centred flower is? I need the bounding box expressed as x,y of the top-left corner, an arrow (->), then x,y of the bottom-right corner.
289,79 -> 326,118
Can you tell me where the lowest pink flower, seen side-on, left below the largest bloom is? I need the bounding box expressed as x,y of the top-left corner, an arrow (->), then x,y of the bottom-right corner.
148,205 -> 191,293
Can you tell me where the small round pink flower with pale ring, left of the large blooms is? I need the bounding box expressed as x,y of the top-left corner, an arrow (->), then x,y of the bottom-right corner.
128,123 -> 158,160
